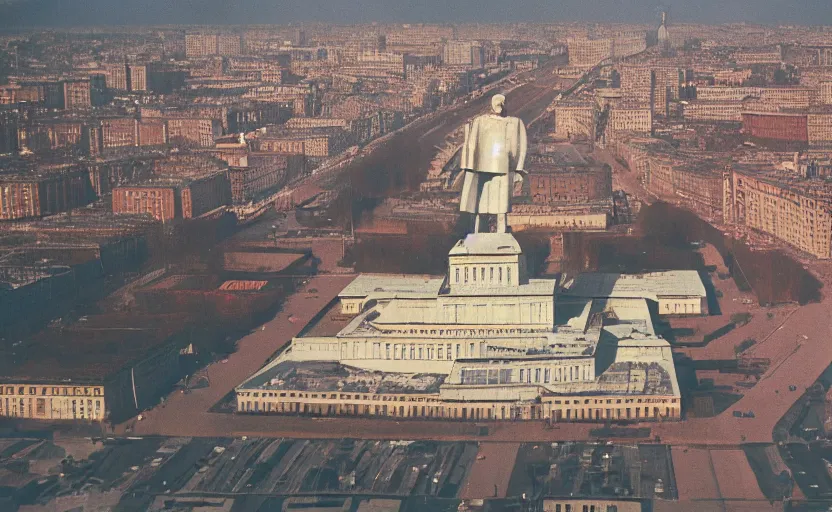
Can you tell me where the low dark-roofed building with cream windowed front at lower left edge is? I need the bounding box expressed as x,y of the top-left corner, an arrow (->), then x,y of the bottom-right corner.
0,315 -> 186,422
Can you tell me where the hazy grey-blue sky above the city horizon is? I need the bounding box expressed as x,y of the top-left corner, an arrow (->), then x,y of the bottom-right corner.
0,0 -> 832,28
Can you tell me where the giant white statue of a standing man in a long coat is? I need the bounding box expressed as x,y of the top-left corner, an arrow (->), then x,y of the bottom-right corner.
459,94 -> 526,233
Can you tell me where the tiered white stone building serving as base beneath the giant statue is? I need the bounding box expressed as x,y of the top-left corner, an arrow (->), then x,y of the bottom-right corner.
236,234 -> 688,421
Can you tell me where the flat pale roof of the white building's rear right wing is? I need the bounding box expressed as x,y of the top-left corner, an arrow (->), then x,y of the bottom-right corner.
563,270 -> 707,300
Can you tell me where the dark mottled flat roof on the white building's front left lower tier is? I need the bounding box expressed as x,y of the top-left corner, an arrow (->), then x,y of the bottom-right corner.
239,361 -> 446,394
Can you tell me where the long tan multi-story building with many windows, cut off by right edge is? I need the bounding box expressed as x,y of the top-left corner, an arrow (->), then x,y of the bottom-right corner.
727,166 -> 832,259
